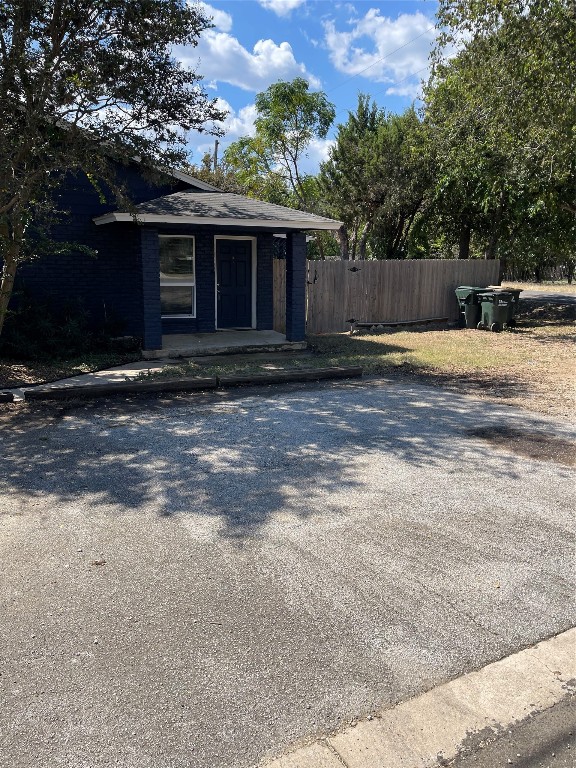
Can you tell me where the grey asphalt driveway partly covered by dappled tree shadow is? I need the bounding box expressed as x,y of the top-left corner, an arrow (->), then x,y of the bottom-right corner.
0,382 -> 576,768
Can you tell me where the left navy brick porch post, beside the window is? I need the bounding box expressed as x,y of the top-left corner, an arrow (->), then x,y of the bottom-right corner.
141,228 -> 162,349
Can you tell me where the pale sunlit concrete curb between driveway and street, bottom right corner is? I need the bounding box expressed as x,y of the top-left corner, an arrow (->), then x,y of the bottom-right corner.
260,628 -> 576,768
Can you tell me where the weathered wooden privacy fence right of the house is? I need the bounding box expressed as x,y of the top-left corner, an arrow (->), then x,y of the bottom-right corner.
274,259 -> 500,333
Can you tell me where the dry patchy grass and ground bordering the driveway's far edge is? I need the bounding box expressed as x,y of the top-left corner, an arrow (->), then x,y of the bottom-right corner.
0,298 -> 576,421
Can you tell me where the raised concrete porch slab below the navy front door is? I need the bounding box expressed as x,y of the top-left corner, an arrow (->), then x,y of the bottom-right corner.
142,330 -> 307,360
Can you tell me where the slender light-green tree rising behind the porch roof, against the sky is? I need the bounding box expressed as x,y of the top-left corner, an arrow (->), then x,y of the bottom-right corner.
224,78 -> 335,210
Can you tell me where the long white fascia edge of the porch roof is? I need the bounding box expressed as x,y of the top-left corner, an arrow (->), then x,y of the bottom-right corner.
93,213 -> 342,231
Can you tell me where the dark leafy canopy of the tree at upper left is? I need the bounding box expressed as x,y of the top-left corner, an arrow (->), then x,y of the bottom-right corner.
0,0 -> 224,332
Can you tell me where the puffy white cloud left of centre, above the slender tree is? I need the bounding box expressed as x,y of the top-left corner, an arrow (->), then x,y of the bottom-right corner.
181,29 -> 320,91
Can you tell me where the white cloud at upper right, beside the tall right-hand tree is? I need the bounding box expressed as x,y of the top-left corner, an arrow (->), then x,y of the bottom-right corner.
324,8 -> 436,96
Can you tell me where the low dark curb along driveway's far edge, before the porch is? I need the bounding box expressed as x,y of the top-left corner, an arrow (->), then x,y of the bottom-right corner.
23,367 -> 362,401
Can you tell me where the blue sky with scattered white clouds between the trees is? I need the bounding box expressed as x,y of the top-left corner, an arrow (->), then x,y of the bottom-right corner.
181,0 -> 437,172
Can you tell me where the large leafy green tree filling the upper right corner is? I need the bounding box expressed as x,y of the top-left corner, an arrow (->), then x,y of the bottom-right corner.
425,0 -> 576,270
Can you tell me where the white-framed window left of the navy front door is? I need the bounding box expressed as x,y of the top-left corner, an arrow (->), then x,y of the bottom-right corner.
160,235 -> 196,317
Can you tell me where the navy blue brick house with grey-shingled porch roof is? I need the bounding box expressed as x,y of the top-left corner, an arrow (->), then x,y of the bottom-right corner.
20,163 -> 340,350
